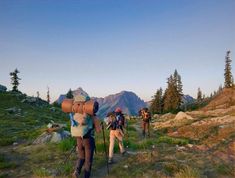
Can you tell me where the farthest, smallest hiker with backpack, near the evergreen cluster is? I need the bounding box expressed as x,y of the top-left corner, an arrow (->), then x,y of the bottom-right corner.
139,108 -> 151,138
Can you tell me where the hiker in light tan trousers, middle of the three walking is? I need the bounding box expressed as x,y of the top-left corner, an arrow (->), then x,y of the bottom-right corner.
106,108 -> 126,164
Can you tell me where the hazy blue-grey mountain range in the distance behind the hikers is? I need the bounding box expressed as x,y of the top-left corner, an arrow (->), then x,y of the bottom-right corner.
56,88 -> 147,118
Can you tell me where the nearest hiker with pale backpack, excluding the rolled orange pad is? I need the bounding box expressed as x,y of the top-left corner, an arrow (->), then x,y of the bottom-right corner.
71,94 -> 101,178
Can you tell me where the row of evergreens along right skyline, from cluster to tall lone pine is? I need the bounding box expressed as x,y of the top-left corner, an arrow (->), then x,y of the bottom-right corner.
150,51 -> 234,114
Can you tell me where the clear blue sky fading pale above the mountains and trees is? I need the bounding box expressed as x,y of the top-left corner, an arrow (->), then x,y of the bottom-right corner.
0,0 -> 235,101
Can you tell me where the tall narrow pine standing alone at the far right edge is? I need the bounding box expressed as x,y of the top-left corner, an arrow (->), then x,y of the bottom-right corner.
224,51 -> 233,88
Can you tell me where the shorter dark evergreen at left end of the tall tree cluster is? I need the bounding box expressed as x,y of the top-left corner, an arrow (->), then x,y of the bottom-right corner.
150,88 -> 163,114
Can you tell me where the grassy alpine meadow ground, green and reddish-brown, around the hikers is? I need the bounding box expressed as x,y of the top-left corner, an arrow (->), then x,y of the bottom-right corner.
0,92 -> 235,178
